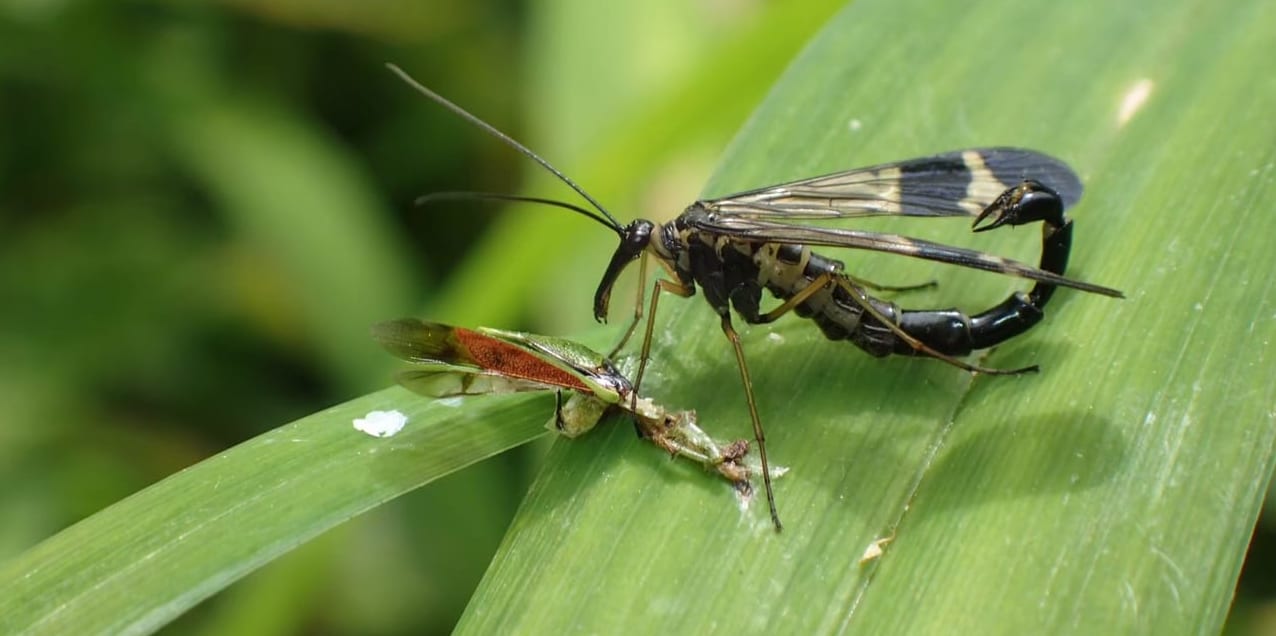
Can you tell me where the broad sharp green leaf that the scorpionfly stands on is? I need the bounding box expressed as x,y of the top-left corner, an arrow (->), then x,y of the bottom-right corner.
459,0 -> 1276,633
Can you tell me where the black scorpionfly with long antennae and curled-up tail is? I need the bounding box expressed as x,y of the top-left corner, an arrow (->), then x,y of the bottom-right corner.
390,65 -> 1122,530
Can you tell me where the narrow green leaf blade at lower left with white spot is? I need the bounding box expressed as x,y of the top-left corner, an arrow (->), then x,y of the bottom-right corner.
0,388 -> 553,633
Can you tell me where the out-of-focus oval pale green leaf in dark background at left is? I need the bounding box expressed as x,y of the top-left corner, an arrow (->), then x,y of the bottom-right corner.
164,86 -> 410,387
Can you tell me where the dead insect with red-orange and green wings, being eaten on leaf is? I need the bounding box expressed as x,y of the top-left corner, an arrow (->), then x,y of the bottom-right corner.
373,318 -> 785,497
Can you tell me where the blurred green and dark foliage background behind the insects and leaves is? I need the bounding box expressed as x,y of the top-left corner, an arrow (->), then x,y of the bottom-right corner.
0,0 -> 1276,633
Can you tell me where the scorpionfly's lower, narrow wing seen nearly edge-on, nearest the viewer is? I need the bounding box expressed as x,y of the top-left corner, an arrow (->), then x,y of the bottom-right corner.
692,215 -> 1124,298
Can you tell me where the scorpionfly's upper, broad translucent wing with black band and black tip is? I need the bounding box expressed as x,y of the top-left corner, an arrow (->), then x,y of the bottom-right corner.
702,148 -> 1082,220
